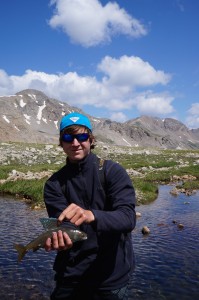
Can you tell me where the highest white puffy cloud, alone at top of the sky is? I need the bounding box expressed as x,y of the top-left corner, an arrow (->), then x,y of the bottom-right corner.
49,0 -> 147,47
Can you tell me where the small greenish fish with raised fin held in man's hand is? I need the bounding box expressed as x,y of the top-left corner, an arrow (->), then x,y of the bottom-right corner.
14,218 -> 87,263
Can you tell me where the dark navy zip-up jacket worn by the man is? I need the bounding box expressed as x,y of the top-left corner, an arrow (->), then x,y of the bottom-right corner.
44,153 -> 136,290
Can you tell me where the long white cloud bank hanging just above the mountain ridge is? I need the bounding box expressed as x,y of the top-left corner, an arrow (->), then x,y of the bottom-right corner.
0,56 -> 174,121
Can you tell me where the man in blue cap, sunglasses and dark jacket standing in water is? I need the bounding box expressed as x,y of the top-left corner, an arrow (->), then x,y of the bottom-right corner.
44,112 -> 136,300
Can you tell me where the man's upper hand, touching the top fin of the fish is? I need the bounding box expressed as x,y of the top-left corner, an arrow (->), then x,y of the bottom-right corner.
58,203 -> 95,226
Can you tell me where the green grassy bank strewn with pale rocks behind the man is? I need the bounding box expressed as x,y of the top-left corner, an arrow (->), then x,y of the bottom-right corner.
0,143 -> 199,206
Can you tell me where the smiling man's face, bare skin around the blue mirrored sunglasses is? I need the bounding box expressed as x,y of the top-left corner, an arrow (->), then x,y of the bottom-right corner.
62,128 -> 91,162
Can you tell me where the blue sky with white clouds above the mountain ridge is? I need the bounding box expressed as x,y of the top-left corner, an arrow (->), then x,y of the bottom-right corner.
0,0 -> 199,128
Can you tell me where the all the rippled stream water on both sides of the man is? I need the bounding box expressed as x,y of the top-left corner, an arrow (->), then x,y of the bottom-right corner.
0,186 -> 199,300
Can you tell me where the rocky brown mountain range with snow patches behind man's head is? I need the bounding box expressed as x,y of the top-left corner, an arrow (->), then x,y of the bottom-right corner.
0,89 -> 199,149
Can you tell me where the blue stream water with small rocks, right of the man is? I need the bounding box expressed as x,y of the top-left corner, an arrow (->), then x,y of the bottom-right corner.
131,186 -> 199,300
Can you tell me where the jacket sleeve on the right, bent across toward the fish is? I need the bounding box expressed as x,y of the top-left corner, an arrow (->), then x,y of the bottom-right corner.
92,161 -> 136,232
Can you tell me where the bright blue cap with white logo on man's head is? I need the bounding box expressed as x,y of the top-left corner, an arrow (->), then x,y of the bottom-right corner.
60,112 -> 92,131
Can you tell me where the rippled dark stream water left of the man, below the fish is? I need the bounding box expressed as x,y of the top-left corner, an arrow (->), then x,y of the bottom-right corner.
0,198 -> 55,300
